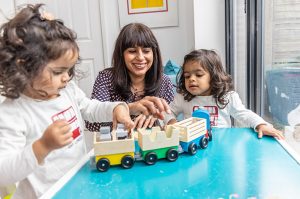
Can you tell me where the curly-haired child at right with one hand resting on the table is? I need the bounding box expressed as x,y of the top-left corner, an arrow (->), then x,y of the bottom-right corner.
164,49 -> 283,138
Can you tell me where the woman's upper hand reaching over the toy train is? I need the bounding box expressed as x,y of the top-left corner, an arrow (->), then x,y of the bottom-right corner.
128,96 -> 171,119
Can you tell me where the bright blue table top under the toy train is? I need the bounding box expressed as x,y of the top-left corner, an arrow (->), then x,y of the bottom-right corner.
54,128 -> 300,199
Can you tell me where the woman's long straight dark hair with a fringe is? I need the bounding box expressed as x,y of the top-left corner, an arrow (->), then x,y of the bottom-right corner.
112,23 -> 163,100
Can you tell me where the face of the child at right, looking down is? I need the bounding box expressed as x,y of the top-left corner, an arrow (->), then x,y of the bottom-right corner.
183,61 -> 211,96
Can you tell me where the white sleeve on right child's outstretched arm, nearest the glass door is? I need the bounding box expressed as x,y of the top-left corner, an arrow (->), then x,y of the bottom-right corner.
228,92 -> 268,129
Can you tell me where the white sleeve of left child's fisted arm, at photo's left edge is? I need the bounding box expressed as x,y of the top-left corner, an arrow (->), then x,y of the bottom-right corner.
0,102 -> 39,186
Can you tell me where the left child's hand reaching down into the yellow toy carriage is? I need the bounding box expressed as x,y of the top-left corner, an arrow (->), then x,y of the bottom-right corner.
113,103 -> 134,129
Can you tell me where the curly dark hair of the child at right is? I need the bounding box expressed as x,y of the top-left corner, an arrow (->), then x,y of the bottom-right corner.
177,49 -> 233,108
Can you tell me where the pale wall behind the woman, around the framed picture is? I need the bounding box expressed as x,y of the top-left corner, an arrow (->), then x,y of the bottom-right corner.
100,0 -> 195,67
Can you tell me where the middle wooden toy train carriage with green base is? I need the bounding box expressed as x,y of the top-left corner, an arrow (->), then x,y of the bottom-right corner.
137,126 -> 179,165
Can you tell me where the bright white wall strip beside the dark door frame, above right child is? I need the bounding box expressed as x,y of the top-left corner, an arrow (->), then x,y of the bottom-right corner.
194,0 -> 226,65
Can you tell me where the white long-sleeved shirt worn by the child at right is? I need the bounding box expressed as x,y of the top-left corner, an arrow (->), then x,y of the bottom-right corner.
164,91 -> 267,129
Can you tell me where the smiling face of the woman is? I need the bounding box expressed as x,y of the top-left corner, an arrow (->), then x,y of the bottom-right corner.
123,47 -> 153,79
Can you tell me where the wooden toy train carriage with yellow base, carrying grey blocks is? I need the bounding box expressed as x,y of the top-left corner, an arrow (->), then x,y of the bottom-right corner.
94,126 -> 135,171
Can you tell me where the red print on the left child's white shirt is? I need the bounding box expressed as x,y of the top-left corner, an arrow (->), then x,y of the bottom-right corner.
51,106 -> 80,139
